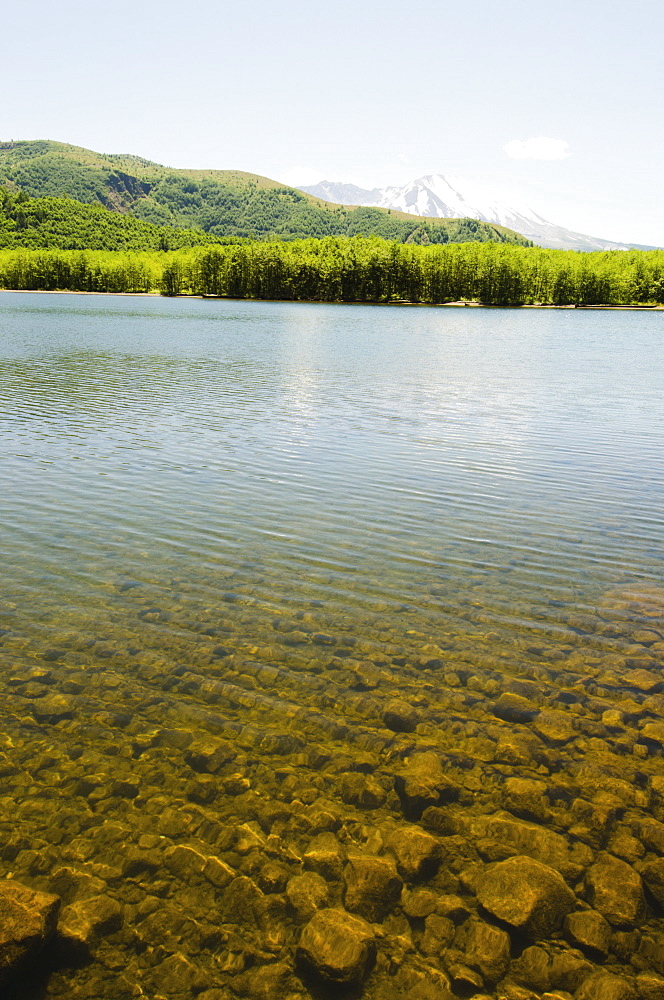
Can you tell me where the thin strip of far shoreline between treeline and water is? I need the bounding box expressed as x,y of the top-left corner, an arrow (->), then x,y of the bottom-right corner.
0,288 -> 664,312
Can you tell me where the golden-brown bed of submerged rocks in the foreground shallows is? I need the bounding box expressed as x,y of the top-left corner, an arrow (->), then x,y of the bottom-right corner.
0,584 -> 664,1000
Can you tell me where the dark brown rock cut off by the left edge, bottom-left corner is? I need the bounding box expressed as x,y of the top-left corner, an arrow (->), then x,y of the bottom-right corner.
0,879 -> 60,982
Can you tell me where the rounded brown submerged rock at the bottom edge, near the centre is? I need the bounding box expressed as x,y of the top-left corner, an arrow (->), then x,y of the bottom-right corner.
297,909 -> 376,984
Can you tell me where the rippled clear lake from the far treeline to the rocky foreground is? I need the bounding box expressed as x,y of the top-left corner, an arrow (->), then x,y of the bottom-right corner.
0,293 -> 664,1000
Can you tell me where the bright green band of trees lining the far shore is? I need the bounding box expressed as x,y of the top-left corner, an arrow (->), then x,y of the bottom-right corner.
0,236 -> 664,305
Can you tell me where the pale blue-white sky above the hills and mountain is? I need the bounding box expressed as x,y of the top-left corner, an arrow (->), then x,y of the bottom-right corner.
0,0 -> 664,246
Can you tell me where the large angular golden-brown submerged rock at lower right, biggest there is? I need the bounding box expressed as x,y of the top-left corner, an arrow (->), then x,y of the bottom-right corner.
477,855 -> 576,937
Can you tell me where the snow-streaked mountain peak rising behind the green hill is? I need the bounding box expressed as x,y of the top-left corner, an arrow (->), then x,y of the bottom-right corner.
301,174 -> 635,250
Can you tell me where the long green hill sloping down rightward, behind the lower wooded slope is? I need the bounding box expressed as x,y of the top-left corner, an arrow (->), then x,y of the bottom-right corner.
0,140 -> 530,249
